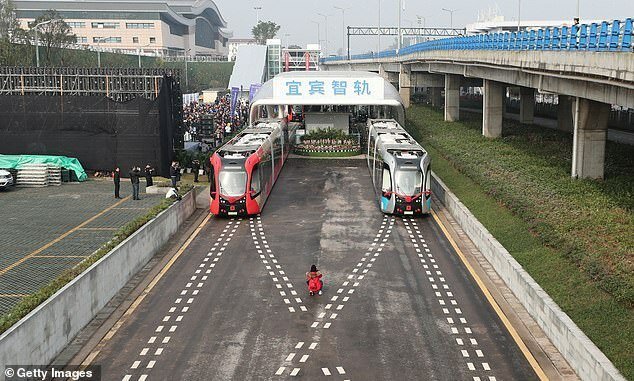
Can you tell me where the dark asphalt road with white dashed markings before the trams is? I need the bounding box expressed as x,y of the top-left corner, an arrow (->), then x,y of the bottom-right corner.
93,159 -> 536,381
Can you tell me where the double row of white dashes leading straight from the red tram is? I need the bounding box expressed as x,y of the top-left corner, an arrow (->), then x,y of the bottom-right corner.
122,219 -> 241,381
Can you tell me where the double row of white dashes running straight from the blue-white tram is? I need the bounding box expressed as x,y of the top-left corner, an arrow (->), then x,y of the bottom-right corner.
403,218 -> 495,381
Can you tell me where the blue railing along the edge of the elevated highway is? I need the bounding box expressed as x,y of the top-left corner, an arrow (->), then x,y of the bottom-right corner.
322,18 -> 633,62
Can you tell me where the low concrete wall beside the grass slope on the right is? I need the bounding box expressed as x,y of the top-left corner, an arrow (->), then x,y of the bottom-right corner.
432,174 -> 625,381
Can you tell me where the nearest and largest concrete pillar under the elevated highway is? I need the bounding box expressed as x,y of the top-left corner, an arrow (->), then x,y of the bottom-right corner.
572,98 -> 610,179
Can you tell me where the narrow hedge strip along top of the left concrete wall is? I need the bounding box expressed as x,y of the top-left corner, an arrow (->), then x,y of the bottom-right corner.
0,185 -> 192,334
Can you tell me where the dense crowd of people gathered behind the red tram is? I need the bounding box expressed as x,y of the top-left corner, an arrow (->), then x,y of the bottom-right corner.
183,95 -> 249,148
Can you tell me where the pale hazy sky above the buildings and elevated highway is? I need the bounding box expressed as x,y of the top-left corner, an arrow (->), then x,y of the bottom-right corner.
214,0 -> 634,54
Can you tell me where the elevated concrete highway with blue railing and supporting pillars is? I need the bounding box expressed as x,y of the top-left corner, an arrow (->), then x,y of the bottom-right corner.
322,19 -> 634,178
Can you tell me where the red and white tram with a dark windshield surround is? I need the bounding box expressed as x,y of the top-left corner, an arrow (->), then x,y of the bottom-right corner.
210,119 -> 296,216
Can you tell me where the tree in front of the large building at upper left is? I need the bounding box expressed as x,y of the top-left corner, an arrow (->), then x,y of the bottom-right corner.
29,9 -> 77,65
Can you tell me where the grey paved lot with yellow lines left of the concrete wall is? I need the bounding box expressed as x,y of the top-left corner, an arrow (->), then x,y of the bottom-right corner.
0,180 -> 163,315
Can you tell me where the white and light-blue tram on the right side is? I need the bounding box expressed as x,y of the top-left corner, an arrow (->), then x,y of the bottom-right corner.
367,119 -> 431,216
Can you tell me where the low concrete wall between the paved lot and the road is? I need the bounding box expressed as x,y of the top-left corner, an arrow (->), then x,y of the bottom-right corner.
0,191 -> 196,372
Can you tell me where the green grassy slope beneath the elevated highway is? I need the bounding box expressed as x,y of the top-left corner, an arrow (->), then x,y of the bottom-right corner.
408,106 -> 634,379
